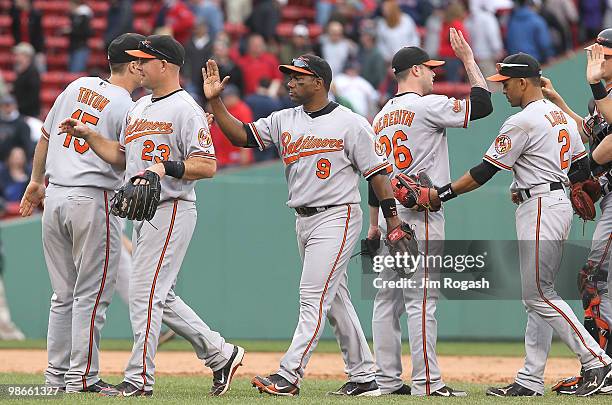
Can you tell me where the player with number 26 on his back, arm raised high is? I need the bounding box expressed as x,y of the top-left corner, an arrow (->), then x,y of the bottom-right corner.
368,28 -> 493,396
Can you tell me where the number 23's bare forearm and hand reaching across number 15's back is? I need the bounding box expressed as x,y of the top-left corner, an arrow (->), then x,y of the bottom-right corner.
60,118 -> 125,169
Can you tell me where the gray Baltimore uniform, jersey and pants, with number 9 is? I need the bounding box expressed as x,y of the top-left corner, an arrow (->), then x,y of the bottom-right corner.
248,103 -> 389,386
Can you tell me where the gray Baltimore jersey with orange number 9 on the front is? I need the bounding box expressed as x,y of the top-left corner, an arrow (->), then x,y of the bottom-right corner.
248,103 -> 389,208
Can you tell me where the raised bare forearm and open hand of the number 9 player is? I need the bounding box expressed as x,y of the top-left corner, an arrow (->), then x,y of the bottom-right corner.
202,60 -> 248,147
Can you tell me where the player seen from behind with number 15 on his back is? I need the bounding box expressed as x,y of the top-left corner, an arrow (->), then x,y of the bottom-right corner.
20,34 -> 144,392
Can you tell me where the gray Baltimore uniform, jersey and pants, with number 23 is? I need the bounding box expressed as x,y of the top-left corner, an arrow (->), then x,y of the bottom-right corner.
120,90 -> 234,391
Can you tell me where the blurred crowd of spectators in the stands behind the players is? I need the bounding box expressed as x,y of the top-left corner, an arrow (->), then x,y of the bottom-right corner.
0,0 -> 612,215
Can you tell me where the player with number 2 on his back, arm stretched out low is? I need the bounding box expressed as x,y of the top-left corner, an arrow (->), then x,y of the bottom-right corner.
406,53 -> 612,396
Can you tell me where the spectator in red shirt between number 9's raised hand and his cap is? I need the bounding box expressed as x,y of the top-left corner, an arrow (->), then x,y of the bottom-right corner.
236,34 -> 283,95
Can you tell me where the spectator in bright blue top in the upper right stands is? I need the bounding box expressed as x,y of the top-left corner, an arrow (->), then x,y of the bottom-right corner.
506,0 -> 553,63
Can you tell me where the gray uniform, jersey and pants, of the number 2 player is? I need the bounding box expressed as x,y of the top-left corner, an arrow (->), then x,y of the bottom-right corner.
484,100 -> 612,393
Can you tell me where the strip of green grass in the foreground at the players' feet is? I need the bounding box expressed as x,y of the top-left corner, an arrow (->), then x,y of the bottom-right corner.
0,374 -> 610,405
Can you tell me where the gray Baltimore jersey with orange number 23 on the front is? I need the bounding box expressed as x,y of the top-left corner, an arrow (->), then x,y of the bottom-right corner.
119,89 -> 215,201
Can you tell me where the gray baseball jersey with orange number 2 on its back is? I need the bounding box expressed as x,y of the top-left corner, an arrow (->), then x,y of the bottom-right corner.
483,99 -> 587,190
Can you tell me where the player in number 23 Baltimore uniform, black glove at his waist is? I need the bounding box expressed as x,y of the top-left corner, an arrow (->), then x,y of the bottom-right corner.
62,35 -> 244,396
